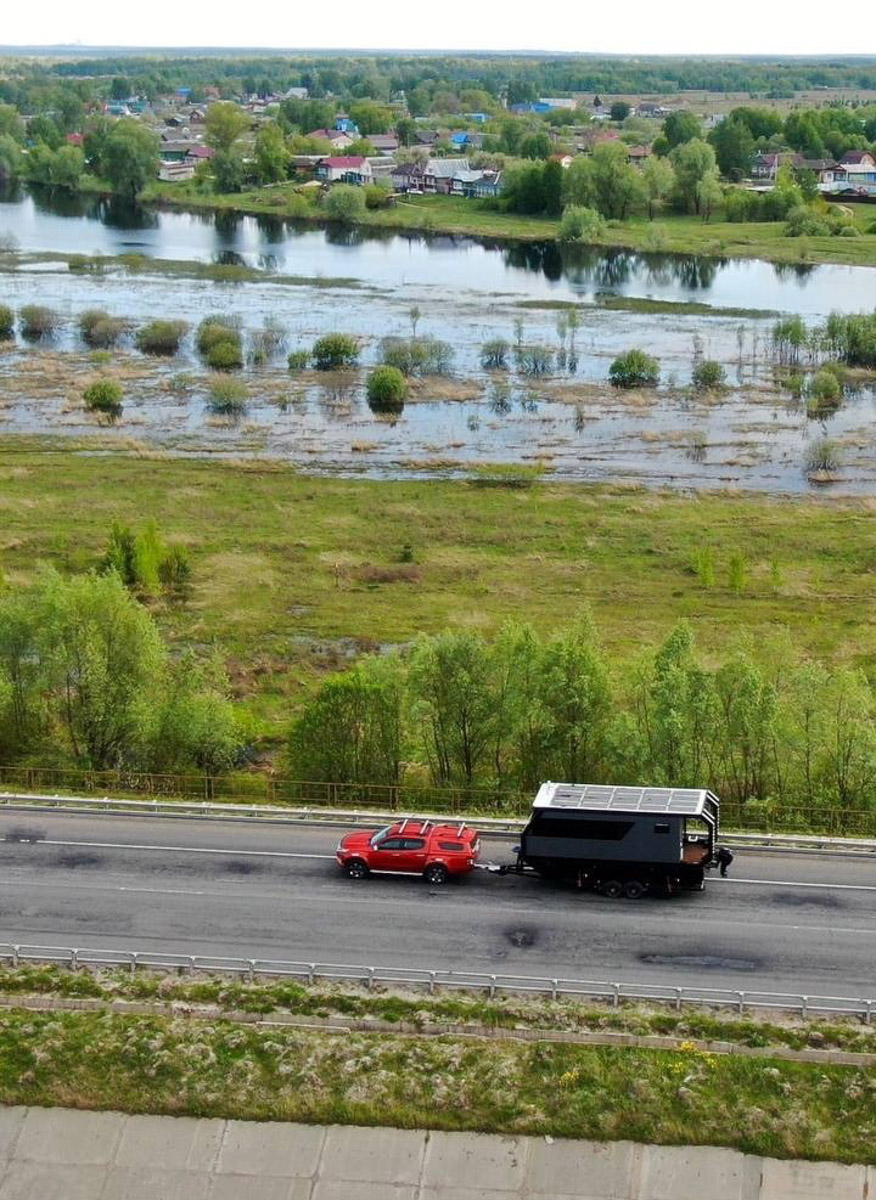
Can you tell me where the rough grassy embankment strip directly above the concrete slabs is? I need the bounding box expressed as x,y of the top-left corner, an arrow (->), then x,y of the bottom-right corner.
0,1009 -> 876,1163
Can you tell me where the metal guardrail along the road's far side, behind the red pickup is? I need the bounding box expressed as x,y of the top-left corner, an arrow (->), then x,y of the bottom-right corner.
0,792 -> 876,856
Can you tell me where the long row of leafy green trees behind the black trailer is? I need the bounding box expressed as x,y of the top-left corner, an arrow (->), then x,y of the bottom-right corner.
286,614 -> 876,810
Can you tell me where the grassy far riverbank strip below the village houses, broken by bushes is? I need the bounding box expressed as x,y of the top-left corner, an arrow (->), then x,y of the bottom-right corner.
143,177 -> 876,266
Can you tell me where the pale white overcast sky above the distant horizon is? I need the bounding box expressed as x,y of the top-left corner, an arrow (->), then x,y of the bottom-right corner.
0,0 -> 876,56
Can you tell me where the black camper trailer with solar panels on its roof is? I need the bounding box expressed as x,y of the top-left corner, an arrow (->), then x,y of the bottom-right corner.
516,782 -> 720,900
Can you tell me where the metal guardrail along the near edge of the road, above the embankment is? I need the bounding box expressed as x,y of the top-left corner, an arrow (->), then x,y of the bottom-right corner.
0,942 -> 876,1025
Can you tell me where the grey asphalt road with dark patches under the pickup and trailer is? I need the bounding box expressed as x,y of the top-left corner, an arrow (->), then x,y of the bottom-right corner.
0,811 -> 876,997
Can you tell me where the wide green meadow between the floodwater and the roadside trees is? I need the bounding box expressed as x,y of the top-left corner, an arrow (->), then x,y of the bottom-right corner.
0,448 -> 876,737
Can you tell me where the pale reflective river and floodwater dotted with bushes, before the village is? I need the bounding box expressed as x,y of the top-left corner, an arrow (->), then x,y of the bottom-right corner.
0,182 -> 876,493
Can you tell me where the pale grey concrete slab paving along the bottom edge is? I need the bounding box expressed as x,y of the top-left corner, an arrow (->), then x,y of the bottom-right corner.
0,1108 -> 876,1200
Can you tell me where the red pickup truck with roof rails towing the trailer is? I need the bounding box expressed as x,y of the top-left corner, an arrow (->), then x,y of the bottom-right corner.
336,818 -> 480,884
